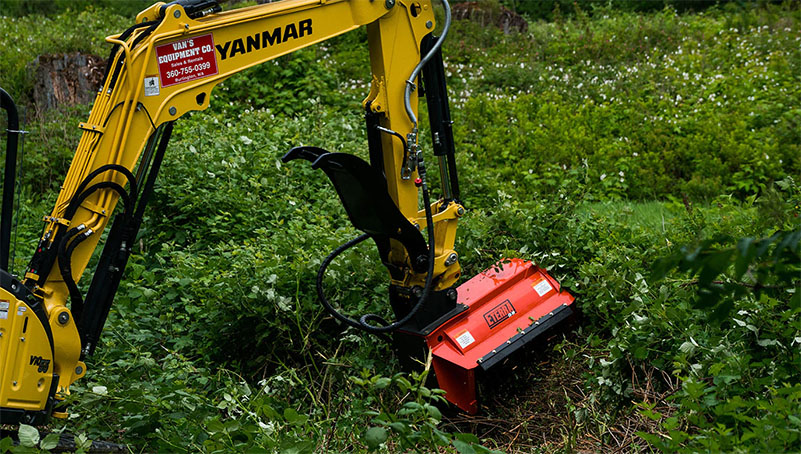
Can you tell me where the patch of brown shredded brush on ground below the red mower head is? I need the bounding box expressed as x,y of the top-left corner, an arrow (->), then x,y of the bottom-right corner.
444,326 -> 678,453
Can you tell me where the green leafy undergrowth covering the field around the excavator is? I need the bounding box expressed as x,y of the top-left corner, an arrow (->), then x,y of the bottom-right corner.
0,0 -> 801,453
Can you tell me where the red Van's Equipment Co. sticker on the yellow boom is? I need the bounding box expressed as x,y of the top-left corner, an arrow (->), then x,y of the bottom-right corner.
156,33 -> 218,88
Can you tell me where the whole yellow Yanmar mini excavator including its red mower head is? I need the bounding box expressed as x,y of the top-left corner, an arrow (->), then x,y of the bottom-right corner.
0,0 -> 573,425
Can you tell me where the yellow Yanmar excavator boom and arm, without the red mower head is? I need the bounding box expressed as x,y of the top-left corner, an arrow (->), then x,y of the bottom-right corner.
0,0 -> 464,423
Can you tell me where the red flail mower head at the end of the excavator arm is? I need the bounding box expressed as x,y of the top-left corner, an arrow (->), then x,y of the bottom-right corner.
426,259 -> 573,414
